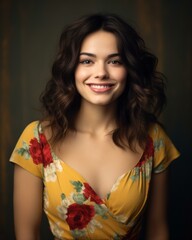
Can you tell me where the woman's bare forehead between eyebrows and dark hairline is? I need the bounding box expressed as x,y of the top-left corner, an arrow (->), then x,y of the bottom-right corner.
81,30 -> 118,52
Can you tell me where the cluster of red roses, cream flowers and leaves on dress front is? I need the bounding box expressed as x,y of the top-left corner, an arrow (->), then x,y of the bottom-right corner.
57,181 -> 108,237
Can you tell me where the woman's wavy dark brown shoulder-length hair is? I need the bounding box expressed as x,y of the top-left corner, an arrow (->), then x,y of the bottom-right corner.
40,14 -> 166,150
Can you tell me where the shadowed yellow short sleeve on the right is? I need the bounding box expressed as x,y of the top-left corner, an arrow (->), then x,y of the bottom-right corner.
150,124 -> 180,173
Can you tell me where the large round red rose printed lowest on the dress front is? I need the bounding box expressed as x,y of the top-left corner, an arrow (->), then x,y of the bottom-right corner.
66,203 -> 95,230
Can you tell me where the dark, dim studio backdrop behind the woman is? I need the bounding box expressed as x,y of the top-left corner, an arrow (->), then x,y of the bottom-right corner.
0,0 -> 192,240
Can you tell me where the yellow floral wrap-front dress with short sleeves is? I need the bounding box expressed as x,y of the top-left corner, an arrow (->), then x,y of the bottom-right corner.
10,121 -> 179,240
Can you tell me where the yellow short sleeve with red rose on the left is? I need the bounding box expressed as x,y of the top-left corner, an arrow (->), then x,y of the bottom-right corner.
10,121 -> 42,178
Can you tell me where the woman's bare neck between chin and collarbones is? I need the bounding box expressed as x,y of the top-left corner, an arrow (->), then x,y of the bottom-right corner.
76,101 -> 116,135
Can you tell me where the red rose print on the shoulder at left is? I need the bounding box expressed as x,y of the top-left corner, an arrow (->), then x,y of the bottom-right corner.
29,134 -> 53,167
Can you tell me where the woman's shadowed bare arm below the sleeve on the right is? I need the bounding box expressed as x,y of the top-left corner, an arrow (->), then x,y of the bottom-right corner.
146,170 -> 169,240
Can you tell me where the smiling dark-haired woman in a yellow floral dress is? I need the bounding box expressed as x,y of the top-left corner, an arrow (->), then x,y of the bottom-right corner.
11,14 -> 179,240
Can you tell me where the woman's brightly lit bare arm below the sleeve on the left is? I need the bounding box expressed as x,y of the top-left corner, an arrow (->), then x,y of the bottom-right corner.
14,164 -> 43,240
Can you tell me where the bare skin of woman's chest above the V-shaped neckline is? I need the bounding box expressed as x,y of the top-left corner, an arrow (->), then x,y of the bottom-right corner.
53,134 -> 142,198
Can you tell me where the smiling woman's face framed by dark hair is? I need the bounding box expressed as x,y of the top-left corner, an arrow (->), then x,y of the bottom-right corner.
75,30 -> 127,105
